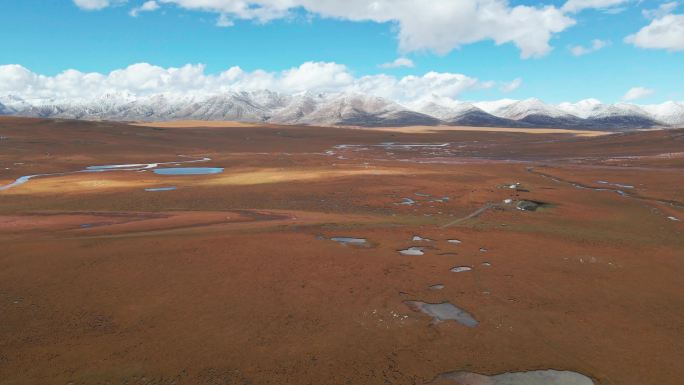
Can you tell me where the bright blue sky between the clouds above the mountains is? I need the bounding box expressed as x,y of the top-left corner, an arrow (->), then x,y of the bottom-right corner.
0,0 -> 684,103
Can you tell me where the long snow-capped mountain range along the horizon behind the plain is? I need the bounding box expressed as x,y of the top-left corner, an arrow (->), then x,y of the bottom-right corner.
0,90 -> 684,130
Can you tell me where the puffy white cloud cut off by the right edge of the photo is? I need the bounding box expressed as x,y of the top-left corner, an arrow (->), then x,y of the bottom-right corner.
625,14 -> 684,51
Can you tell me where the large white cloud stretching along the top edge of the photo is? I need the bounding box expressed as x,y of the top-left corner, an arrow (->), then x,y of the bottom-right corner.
83,0 -> 576,58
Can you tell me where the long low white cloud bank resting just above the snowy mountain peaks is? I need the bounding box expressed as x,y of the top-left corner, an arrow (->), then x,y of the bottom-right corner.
0,62 -> 494,101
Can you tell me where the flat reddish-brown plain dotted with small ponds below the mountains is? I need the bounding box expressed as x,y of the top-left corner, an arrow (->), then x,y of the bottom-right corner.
0,117 -> 684,385
